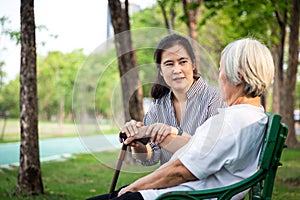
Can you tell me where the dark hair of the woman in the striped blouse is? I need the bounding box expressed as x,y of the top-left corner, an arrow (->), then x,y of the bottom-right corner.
151,34 -> 200,99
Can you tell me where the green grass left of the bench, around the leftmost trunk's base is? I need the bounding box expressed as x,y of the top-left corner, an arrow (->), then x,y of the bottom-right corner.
0,151 -> 154,200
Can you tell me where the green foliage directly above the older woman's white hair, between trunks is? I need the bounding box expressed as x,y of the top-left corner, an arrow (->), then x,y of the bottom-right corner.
199,0 -> 276,64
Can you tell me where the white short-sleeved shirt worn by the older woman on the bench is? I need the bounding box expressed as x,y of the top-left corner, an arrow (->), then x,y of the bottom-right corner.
139,104 -> 268,200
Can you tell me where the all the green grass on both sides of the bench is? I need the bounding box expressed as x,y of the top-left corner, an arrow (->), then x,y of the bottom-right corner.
0,149 -> 300,200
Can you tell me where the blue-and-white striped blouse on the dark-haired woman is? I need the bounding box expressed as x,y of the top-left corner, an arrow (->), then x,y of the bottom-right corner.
134,77 -> 226,166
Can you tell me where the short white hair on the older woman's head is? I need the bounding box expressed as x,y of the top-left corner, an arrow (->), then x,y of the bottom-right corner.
221,38 -> 274,97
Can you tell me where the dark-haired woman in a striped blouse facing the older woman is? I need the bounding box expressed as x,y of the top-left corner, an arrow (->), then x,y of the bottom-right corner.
121,34 -> 226,166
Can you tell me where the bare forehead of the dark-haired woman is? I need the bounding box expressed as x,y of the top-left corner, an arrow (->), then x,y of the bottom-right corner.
161,45 -> 190,61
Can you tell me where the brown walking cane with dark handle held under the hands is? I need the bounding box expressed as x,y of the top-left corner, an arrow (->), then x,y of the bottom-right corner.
109,133 -> 149,193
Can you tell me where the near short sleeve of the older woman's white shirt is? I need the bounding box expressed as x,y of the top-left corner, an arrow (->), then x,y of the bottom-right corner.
178,112 -> 236,179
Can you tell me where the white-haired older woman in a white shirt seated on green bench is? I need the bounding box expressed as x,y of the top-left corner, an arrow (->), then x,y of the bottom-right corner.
86,38 -> 274,199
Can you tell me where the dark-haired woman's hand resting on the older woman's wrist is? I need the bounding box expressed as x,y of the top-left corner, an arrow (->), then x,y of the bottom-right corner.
145,123 -> 178,144
